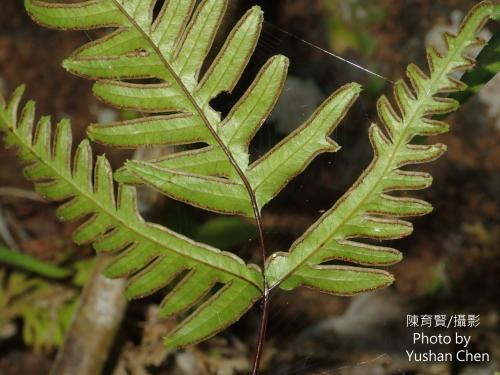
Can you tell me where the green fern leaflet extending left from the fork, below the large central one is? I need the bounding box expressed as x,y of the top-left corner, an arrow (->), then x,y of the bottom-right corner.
0,88 -> 263,347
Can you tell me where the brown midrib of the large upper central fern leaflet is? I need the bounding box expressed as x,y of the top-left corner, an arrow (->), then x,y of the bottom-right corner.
112,0 -> 264,226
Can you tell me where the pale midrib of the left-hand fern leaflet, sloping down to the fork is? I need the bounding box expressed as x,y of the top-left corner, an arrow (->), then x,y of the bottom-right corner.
0,113 -> 261,290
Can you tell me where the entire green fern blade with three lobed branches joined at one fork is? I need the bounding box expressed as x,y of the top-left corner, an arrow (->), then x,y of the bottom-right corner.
0,0 -> 493,370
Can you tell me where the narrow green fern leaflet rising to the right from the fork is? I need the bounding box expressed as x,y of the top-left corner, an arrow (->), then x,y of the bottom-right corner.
266,2 -> 493,295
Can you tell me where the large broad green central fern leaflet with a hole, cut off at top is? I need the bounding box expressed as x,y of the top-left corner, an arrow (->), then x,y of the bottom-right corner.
25,0 -> 360,217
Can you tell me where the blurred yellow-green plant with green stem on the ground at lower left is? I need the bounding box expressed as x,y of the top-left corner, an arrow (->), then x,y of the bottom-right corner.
0,246 -> 94,350
